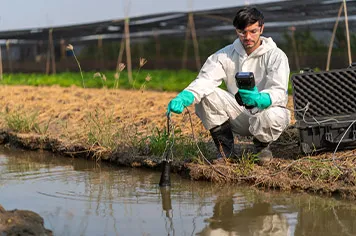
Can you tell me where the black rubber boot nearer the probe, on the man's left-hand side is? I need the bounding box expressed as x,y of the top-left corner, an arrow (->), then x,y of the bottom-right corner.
210,121 -> 234,158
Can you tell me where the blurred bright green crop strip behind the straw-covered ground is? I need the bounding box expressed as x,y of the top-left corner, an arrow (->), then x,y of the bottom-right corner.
0,68 -> 296,94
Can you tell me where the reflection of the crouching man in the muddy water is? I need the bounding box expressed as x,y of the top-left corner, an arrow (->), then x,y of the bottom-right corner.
199,192 -> 298,236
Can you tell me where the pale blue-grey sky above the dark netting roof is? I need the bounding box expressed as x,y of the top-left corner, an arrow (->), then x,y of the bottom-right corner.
0,0 -> 279,31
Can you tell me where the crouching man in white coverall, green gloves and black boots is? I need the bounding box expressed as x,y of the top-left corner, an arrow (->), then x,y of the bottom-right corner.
167,7 -> 290,164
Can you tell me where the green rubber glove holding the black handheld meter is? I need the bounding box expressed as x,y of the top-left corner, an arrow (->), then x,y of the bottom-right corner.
238,86 -> 272,109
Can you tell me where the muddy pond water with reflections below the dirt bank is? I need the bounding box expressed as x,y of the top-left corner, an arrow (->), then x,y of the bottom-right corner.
0,147 -> 356,236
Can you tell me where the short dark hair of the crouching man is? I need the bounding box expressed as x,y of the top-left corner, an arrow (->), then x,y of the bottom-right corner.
233,7 -> 264,30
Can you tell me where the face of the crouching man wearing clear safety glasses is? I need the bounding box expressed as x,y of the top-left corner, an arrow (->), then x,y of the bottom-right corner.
236,22 -> 264,50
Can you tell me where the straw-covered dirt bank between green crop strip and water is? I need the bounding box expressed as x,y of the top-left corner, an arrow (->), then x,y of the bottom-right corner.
0,86 -> 356,198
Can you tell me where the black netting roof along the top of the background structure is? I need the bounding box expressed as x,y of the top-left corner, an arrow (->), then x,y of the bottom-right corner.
0,0 -> 356,41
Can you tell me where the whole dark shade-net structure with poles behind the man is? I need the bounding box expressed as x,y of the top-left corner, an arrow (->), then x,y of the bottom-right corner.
0,0 -> 356,75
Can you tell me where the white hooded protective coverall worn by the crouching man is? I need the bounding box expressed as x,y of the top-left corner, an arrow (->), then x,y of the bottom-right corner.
185,36 -> 290,142
